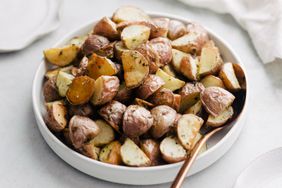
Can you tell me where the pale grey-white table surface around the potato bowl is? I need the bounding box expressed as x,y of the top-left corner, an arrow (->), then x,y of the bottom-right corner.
0,0 -> 282,188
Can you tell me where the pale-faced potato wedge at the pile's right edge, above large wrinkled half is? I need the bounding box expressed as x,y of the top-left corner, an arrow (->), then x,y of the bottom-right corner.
219,63 -> 241,91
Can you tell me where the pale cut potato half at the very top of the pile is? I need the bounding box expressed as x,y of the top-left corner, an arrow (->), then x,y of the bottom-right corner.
112,6 -> 150,23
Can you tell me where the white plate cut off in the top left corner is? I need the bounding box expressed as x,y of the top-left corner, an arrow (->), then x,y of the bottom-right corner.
0,0 -> 62,52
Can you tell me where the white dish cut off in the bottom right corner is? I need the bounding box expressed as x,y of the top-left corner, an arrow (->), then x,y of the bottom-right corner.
234,147 -> 282,188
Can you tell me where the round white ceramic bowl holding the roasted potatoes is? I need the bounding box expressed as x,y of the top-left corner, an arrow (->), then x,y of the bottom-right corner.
32,13 -> 248,185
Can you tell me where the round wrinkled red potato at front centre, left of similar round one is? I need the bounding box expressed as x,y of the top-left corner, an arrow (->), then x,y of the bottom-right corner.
123,105 -> 153,138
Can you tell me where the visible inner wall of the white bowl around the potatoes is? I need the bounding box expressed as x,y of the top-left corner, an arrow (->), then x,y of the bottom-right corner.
32,13 -> 248,170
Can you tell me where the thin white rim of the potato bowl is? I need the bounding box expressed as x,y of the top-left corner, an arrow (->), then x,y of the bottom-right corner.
32,11 -> 249,172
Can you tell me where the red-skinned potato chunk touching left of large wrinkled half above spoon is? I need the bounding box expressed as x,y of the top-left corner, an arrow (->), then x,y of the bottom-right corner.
179,82 -> 205,112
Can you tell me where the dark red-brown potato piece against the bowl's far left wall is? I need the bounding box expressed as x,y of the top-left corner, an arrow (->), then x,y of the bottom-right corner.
43,78 -> 61,102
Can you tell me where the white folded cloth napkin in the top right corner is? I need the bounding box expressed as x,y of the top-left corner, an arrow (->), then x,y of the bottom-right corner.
180,0 -> 282,63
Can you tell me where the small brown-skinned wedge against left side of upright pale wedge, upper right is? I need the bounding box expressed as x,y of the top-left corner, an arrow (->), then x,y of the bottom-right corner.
180,56 -> 198,81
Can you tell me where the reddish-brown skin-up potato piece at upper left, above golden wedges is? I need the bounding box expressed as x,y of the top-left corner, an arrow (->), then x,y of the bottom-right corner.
81,35 -> 110,55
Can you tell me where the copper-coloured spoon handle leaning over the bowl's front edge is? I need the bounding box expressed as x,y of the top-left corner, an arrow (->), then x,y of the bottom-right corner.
171,127 -> 223,188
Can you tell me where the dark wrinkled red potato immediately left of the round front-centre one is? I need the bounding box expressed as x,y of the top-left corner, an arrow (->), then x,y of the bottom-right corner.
99,100 -> 126,132
